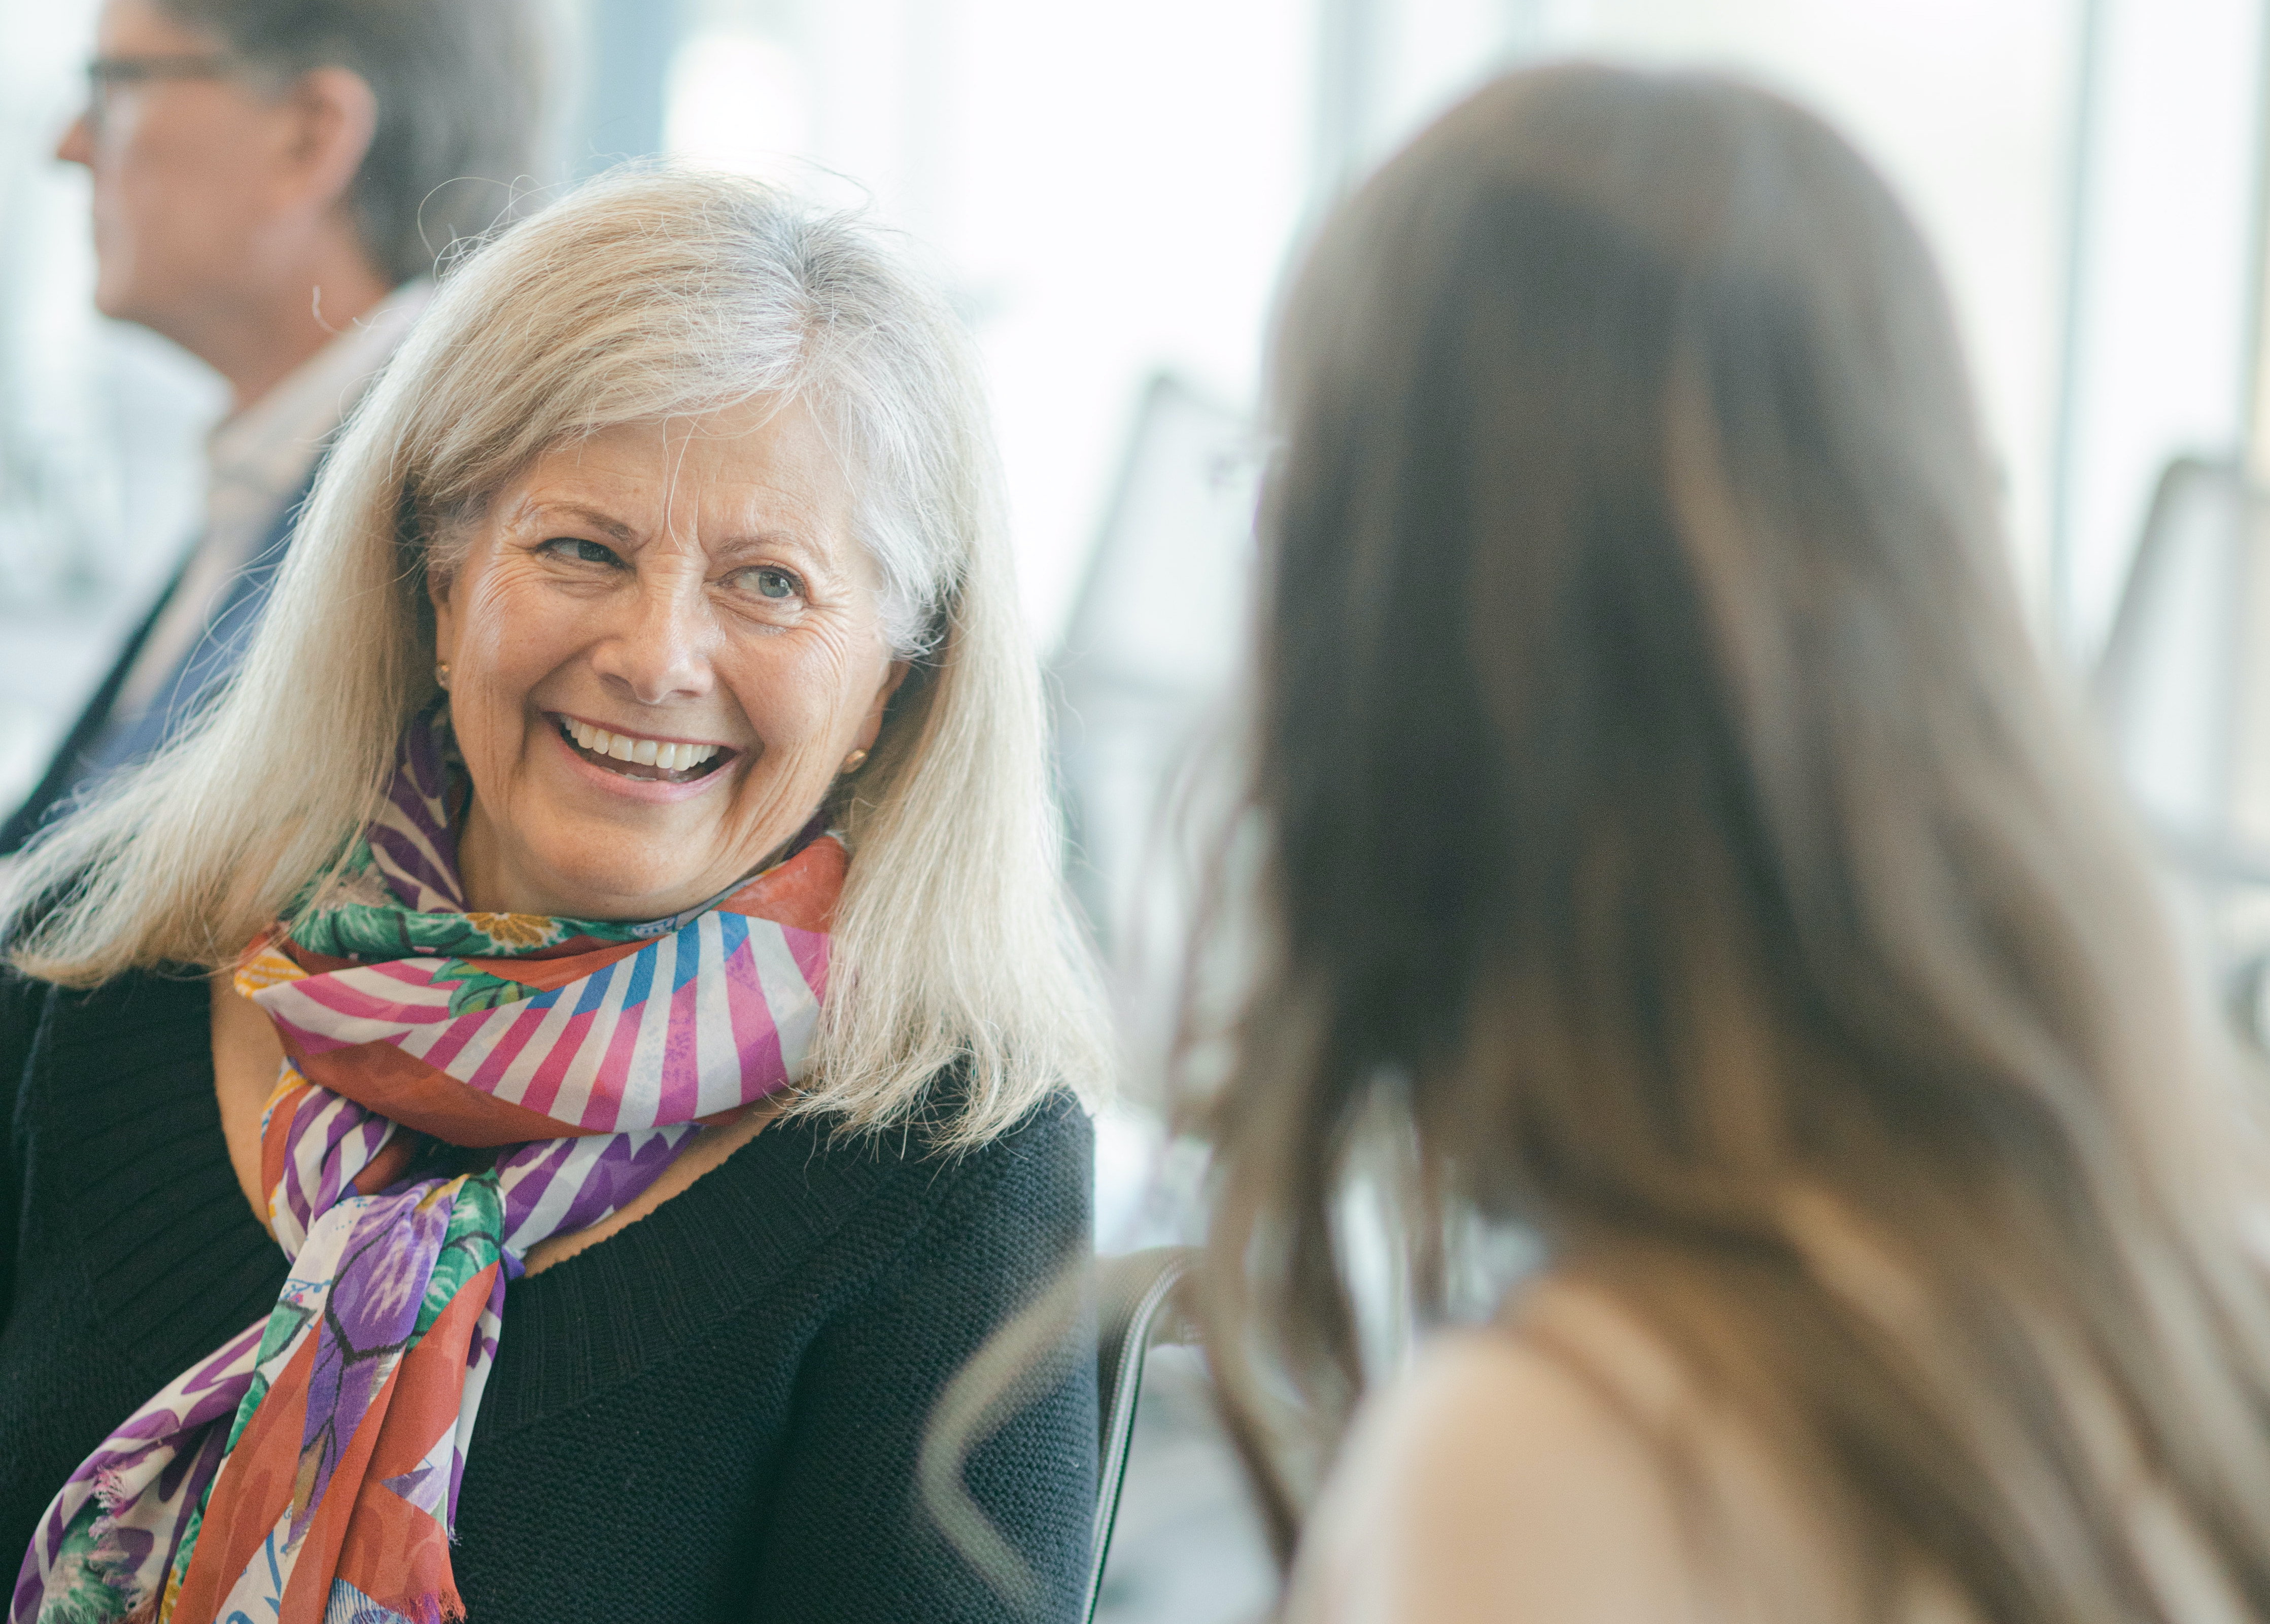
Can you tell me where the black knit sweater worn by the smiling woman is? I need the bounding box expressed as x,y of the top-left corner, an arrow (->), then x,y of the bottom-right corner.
0,975 -> 1096,1624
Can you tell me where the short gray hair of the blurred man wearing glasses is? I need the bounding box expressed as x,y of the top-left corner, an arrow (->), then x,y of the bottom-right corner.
159,0 -> 552,282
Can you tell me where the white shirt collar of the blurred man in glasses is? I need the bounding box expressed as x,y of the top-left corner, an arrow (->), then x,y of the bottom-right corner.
111,277 -> 434,729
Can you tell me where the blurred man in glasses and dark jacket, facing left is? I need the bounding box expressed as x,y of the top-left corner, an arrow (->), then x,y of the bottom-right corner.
0,0 -> 547,856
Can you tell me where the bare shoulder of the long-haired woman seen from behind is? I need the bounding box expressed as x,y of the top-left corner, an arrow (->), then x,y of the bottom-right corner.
1294,1299 -> 1698,1624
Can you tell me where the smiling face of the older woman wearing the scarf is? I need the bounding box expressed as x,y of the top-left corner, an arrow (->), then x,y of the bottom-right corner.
431,402 -> 904,920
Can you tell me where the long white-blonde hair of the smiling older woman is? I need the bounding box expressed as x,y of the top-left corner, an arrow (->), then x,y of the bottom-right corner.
0,168 -> 1108,1145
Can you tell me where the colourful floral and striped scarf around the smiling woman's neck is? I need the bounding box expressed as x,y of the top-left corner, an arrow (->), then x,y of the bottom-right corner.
9,706 -> 844,1624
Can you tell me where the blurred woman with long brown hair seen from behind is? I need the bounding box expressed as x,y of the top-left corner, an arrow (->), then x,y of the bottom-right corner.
1206,68 -> 2270,1624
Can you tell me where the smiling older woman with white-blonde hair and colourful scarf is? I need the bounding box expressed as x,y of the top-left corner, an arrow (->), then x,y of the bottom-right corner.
0,172 -> 1103,1624
